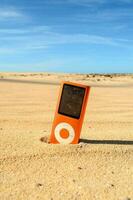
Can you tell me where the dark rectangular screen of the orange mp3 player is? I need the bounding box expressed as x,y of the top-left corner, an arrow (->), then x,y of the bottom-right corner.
58,84 -> 85,119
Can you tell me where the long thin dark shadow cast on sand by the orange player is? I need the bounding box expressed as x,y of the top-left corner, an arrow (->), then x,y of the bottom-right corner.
79,139 -> 133,145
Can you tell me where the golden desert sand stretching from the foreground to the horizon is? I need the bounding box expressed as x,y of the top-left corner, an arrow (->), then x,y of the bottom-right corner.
0,73 -> 133,200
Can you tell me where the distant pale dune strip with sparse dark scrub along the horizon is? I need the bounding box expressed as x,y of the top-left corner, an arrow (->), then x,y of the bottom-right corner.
0,72 -> 133,86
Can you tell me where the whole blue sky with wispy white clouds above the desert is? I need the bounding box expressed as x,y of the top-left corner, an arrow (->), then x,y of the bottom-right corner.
0,0 -> 133,73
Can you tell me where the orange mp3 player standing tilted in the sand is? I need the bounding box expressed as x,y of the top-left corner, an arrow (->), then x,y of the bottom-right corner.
50,82 -> 90,144
